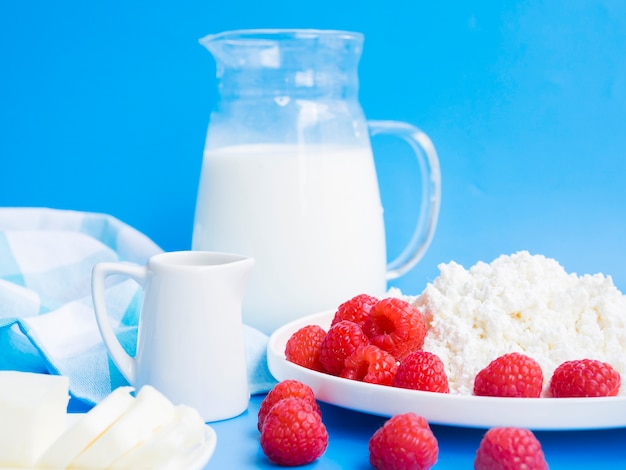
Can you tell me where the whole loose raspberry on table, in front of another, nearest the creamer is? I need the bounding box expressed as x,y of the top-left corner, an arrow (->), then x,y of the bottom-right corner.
261,398 -> 328,466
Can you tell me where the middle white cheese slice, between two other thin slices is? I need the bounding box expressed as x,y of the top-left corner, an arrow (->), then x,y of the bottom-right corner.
70,385 -> 175,470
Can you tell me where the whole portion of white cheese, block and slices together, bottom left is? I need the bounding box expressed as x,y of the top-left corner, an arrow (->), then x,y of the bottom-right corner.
0,371 -> 210,470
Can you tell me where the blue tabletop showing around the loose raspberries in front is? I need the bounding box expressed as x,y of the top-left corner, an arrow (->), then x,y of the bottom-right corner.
206,395 -> 626,470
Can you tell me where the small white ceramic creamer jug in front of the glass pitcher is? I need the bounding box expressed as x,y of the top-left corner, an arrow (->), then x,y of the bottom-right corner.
92,251 -> 254,421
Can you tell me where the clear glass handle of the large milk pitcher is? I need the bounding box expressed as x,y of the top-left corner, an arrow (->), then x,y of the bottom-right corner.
367,121 -> 441,280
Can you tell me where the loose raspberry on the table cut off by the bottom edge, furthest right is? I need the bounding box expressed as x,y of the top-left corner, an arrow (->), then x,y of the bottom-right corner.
474,428 -> 548,470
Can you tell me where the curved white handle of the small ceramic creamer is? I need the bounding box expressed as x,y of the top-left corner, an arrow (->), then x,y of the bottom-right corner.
91,262 -> 148,385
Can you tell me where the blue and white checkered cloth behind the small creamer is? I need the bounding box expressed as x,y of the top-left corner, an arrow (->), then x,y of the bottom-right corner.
0,208 -> 275,408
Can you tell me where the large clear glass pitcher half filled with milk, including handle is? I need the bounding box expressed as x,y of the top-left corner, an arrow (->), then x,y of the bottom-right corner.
192,30 -> 440,334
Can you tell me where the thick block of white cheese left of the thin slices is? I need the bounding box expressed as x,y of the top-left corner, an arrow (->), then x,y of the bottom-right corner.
0,371 -> 69,468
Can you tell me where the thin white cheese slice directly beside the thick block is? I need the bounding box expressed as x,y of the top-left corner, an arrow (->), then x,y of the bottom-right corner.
37,387 -> 135,469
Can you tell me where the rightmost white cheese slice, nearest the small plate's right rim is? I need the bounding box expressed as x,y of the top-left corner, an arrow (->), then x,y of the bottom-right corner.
110,405 -> 205,469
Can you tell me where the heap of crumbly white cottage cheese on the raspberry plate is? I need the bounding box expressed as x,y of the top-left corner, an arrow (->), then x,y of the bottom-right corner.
413,251 -> 626,395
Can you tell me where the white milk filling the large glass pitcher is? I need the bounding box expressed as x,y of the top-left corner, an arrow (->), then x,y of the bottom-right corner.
193,144 -> 386,334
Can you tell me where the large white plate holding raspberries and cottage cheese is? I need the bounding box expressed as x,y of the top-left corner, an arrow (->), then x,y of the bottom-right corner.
267,312 -> 626,430
